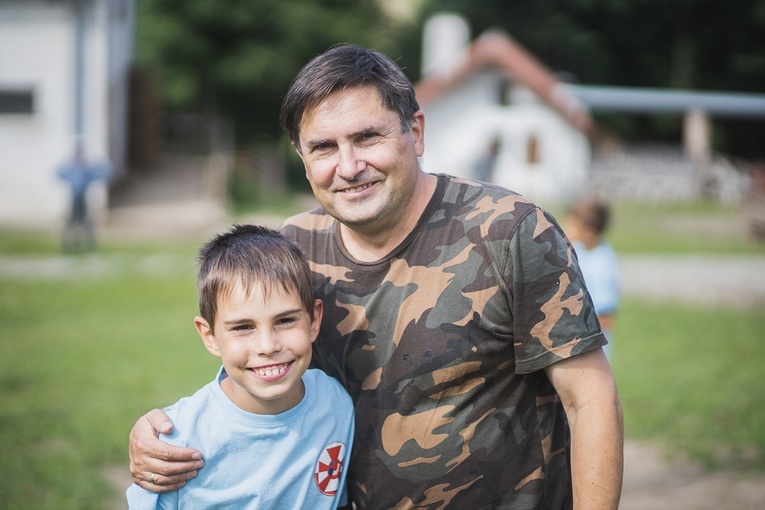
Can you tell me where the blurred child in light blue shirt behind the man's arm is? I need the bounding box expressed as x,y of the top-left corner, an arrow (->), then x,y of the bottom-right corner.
564,197 -> 621,358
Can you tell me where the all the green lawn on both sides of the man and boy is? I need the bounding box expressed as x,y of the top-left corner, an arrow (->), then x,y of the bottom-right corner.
0,199 -> 765,509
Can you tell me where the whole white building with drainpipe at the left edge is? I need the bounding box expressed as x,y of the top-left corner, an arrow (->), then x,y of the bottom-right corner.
0,0 -> 134,225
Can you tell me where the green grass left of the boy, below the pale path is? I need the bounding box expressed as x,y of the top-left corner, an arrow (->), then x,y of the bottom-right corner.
0,258 -> 217,509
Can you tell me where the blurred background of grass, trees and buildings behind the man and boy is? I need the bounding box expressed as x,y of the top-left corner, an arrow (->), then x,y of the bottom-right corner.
0,0 -> 765,509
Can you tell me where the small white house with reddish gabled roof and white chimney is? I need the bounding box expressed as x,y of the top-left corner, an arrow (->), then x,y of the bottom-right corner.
415,14 -> 593,200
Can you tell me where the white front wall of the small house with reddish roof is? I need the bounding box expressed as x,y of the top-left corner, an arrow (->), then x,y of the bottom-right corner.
422,72 -> 590,205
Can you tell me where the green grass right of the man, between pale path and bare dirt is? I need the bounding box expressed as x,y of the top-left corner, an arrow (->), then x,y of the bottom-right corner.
612,299 -> 765,470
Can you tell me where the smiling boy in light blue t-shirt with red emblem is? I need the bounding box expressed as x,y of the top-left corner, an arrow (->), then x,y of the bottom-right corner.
127,225 -> 353,510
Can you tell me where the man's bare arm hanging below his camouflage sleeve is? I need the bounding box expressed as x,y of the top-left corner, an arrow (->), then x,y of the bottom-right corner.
545,349 -> 624,510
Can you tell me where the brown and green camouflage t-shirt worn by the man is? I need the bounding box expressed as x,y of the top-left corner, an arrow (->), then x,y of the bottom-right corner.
282,175 -> 606,510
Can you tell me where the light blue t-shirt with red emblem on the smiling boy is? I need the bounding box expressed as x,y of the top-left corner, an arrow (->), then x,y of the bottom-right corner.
127,368 -> 353,510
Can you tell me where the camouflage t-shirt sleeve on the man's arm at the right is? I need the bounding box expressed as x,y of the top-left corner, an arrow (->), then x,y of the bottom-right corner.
505,208 -> 607,374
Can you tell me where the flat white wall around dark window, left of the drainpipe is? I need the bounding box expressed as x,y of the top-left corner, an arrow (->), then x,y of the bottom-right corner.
0,2 -> 74,223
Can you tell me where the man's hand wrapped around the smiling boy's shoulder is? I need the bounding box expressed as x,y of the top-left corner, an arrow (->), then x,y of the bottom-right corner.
129,409 -> 204,492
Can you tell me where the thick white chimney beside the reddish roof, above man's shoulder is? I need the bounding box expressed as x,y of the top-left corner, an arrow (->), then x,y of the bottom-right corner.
422,12 -> 470,77
